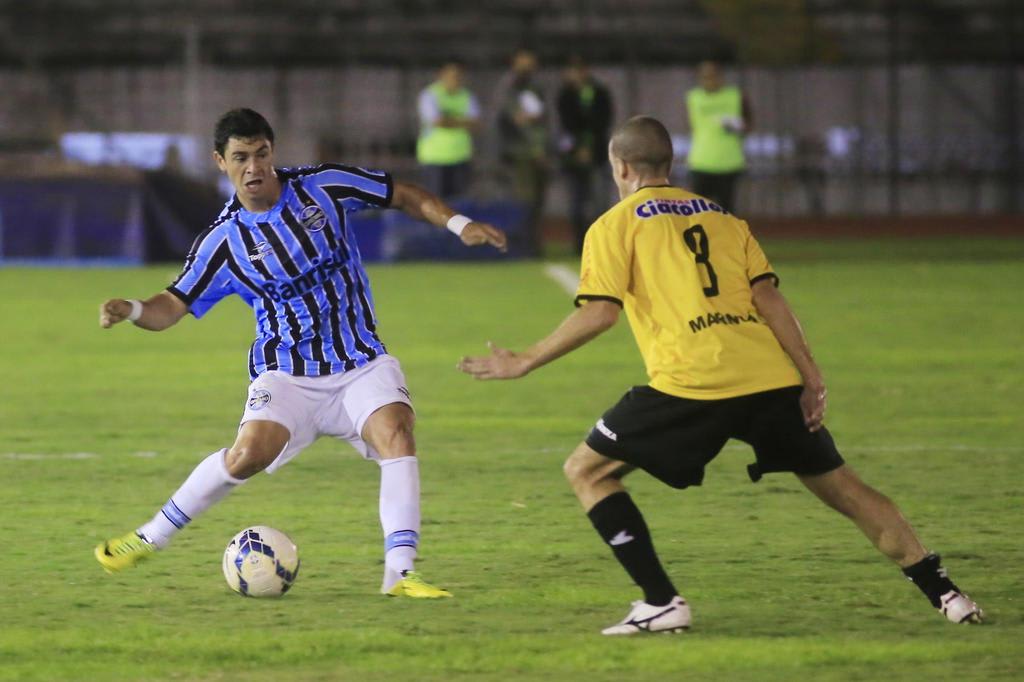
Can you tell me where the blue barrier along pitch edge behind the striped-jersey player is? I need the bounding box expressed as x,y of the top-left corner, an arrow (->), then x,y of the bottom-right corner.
0,178 -> 527,265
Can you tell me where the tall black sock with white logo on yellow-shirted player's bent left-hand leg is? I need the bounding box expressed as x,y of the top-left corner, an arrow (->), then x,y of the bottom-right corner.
587,492 -> 678,606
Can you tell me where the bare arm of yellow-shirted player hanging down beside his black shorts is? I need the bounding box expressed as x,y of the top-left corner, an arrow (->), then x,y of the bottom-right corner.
752,280 -> 828,431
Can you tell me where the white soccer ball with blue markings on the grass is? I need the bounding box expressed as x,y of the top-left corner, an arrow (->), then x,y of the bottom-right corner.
223,525 -> 299,597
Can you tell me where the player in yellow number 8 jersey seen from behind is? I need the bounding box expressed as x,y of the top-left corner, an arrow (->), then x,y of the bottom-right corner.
459,117 -> 982,635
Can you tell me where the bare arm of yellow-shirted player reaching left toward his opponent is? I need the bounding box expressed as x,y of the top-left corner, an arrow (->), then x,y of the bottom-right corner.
456,301 -> 620,379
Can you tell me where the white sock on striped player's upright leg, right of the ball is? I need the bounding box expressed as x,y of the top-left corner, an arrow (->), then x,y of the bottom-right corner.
380,456 -> 420,583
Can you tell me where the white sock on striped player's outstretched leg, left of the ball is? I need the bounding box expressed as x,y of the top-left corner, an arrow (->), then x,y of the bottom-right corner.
138,449 -> 245,549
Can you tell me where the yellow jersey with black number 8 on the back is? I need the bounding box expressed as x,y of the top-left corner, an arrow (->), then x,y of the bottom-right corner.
575,185 -> 803,400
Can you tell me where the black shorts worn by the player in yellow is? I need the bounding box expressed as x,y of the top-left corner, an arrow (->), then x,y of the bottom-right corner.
587,386 -> 843,487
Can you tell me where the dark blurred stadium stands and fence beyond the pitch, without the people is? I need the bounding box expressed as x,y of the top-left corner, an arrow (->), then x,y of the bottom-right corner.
0,0 -> 1024,263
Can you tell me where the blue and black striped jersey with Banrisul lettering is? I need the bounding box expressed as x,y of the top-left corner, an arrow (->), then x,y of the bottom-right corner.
167,164 -> 393,379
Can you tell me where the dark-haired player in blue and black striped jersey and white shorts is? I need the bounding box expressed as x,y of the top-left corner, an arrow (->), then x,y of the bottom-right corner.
95,109 -> 506,598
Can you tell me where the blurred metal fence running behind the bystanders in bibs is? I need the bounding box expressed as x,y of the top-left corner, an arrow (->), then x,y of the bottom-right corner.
0,61 -> 1024,216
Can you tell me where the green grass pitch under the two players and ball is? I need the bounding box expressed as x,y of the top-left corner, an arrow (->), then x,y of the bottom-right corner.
0,240 -> 1024,682
